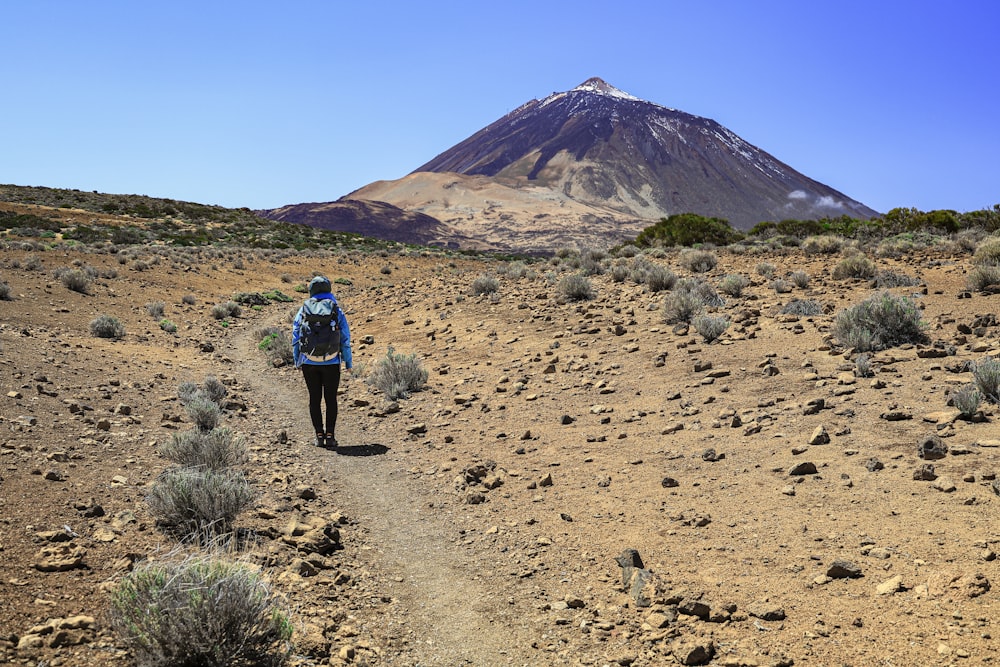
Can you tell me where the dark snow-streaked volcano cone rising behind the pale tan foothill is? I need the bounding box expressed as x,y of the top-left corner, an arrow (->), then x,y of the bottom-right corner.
416,79 -> 876,229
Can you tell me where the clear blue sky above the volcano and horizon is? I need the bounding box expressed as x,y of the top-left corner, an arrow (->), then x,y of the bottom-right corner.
0,0 -> 1000,212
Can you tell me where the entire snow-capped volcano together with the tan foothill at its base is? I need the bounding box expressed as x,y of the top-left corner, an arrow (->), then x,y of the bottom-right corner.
274,77 -> 876,252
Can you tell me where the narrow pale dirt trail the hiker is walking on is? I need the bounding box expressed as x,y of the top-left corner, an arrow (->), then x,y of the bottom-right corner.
231,332 -> 530,665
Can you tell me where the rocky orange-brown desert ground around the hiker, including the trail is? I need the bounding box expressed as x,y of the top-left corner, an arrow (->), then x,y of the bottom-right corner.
0,234 -> 1000,667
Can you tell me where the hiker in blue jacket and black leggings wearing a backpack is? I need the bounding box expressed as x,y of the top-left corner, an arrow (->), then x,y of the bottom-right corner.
292,276 -> 353,449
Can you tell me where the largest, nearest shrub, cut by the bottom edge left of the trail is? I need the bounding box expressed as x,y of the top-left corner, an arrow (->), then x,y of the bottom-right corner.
109,556 -> 293,667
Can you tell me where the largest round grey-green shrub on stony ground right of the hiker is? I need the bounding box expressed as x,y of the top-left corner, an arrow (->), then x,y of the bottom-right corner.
833,292 -> 927,352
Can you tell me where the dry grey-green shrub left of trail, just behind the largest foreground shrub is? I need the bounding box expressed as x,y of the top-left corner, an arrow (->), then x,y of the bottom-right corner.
146,467 -> 256,541
